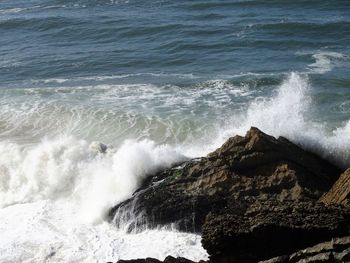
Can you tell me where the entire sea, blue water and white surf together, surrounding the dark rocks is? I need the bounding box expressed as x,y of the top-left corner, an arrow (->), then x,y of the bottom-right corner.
0,0 -> 350,262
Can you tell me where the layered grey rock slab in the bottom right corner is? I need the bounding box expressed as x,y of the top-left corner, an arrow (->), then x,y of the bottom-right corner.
259,236 -> 350,263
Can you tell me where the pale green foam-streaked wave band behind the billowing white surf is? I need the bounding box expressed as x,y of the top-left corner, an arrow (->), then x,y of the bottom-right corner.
0,80 -> 255,145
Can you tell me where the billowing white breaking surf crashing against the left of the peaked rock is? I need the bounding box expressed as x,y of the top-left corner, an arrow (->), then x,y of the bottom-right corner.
0,137 -> 185,224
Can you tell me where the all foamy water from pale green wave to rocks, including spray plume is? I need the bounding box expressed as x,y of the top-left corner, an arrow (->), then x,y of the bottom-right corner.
0,73 -> 350,262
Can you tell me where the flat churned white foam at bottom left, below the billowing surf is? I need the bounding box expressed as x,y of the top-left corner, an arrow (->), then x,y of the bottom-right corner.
0,200 -> 208,262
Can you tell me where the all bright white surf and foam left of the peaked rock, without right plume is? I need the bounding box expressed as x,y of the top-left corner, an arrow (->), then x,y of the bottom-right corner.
0,137 -> 207,262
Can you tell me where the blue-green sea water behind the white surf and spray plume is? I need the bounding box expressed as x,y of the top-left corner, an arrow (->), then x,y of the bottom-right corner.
0,1 -> 350,147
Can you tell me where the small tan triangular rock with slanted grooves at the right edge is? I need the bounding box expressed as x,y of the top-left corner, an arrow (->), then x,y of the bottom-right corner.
320,169 -> 350,206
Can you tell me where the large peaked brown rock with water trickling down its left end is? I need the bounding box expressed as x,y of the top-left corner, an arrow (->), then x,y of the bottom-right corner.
109,128 -> 340,232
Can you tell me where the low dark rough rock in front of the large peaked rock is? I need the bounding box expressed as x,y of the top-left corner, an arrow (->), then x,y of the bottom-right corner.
202,201 -> 350,263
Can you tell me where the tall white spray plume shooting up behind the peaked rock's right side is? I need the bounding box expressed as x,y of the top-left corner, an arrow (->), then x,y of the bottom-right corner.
205,73 -> 350,168
